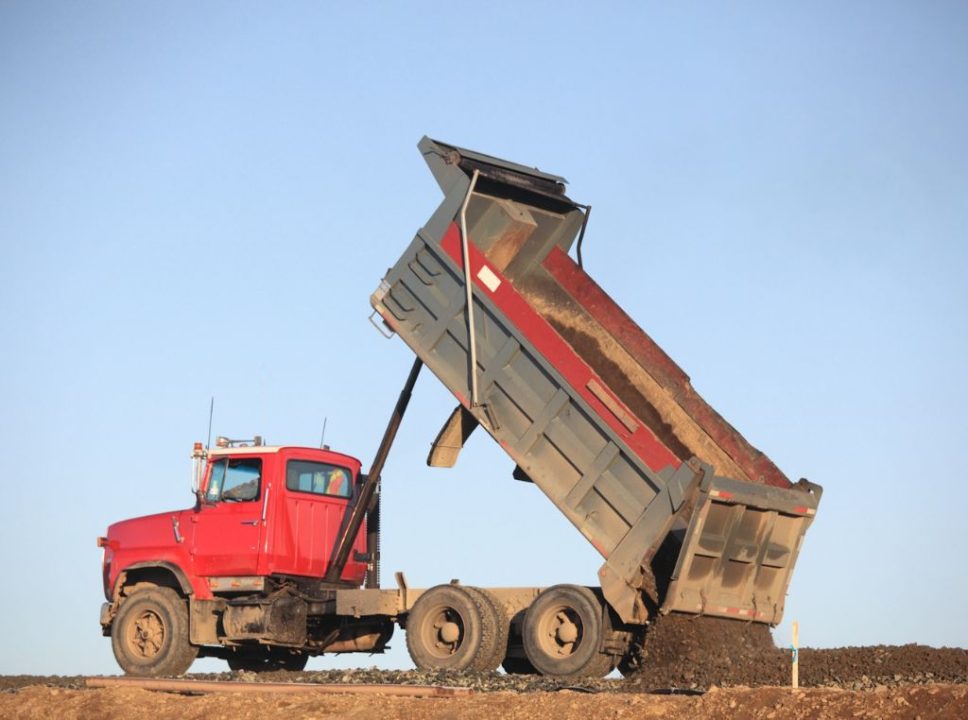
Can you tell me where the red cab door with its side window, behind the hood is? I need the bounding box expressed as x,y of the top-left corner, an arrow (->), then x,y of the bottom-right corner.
191,456 -> 270,577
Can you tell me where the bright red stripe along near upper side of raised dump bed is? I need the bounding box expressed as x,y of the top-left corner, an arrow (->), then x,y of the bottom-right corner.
440,224 -> 682,472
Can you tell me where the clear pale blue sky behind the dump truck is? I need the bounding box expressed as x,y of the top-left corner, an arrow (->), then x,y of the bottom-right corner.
0,0 -> 968,674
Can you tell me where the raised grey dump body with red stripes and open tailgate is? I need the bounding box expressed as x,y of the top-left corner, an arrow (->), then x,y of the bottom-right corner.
371,138 -> 820,624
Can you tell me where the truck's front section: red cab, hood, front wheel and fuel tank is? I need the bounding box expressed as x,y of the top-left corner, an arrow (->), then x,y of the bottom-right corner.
98,442 -> 370,674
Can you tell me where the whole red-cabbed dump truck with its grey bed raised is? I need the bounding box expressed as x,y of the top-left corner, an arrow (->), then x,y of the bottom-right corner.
98,138 -> 822,677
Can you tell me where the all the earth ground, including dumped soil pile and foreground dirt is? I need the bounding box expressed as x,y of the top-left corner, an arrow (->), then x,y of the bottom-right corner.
0,616 -> 968,720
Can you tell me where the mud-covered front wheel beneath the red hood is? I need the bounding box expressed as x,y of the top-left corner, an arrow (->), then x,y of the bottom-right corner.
111,587 -> 198,677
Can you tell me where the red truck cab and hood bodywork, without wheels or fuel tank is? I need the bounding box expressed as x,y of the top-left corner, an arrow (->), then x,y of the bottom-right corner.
102,446 -> 366,601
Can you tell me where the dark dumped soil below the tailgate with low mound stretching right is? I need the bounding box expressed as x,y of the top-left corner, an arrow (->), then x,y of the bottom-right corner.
628,615 -> 968,690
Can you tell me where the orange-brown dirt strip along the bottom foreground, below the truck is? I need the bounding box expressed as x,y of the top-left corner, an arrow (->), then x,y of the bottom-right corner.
0,684 -> 968,720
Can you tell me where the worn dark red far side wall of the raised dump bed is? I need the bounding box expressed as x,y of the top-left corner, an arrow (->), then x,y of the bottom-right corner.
542,246 -> 791,488
